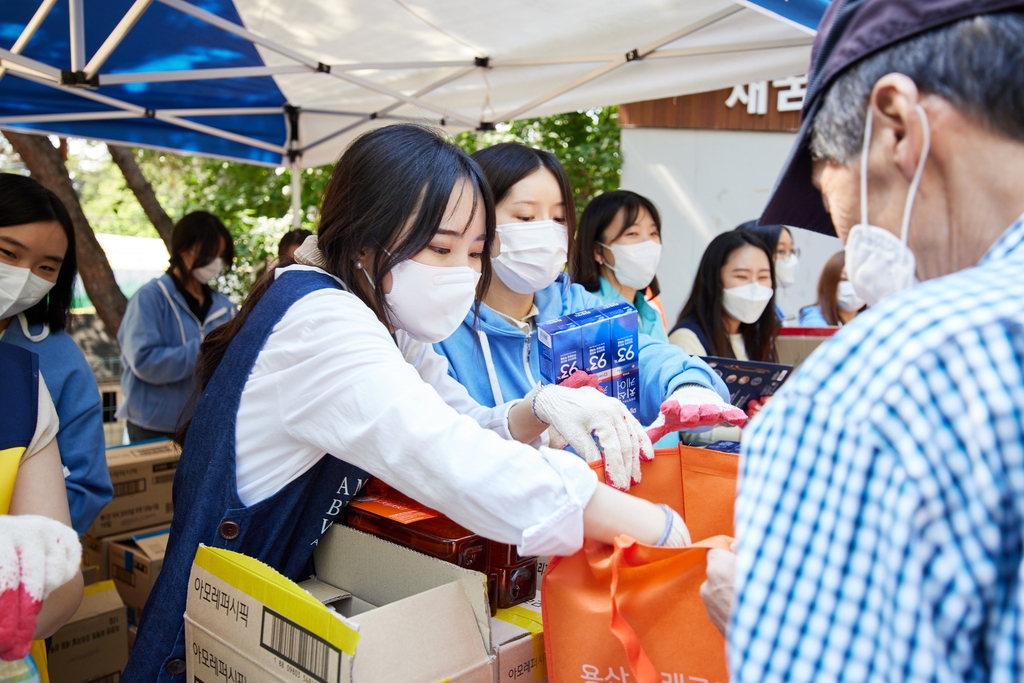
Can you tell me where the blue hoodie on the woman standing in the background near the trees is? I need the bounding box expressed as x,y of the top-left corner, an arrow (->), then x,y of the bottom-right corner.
117,272 -> 234,432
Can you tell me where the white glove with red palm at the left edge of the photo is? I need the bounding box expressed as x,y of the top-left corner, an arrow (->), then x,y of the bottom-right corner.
0,515 -> 82,661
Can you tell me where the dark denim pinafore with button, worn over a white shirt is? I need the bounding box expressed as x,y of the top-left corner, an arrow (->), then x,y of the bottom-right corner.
121,270 -> 369,683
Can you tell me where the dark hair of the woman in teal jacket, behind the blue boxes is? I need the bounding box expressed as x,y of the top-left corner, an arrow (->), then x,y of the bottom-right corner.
569,189 -> 662,296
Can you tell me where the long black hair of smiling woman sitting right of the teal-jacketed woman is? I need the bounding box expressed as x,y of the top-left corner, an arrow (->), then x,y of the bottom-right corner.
676,230 -> 779,362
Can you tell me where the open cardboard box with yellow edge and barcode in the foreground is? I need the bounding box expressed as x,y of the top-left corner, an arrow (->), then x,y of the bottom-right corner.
185,524 -> 495,683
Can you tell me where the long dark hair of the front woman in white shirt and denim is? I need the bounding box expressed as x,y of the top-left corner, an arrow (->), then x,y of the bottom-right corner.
185,124 -> 495,442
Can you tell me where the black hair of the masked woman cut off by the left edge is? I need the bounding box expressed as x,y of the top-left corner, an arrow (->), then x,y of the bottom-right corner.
0,173 -> 78,332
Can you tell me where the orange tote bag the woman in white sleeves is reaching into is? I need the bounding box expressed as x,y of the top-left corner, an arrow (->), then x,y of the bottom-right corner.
542,446 -> 737,683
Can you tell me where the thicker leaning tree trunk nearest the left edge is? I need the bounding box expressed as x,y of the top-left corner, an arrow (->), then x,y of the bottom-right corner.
4,130 -> 128,337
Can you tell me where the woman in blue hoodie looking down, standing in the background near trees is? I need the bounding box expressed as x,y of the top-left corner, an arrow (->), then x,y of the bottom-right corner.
117,211 -> 234,442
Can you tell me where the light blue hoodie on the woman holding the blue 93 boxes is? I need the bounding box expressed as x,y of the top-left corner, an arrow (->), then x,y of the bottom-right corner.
434,273 -> 729,430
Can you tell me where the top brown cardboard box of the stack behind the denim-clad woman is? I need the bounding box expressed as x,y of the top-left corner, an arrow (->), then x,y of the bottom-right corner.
88,439 -> 181,539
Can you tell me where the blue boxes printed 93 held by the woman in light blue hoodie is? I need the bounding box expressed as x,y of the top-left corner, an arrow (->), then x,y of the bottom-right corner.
537,301 -> 640,416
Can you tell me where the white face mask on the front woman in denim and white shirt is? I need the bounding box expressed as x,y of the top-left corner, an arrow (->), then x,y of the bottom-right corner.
384,259 -> 480,344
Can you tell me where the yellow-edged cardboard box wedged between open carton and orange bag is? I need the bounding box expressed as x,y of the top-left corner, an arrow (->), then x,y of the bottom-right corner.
490,592 -> 548,683
